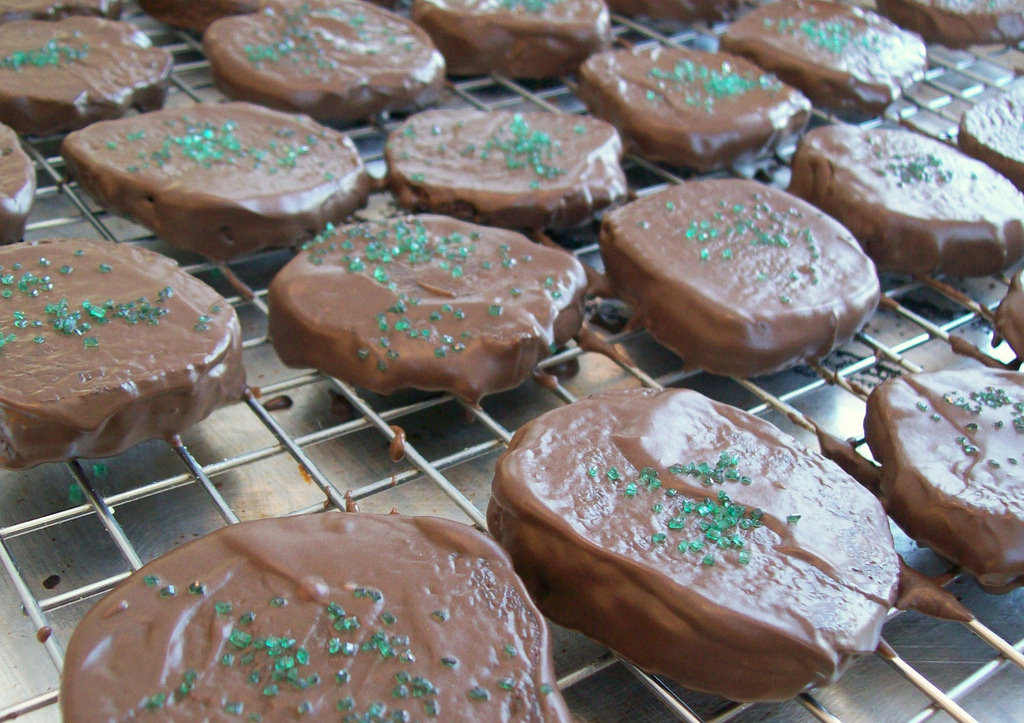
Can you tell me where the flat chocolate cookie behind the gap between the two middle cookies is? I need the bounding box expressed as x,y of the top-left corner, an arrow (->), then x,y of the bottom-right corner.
384,110 -> 627,229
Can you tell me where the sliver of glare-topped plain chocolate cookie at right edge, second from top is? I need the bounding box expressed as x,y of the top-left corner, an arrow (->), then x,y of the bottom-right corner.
957,88 -> 1024,192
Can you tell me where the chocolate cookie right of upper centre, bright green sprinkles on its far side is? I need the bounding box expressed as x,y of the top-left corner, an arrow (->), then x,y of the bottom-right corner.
578,46 -> 811,171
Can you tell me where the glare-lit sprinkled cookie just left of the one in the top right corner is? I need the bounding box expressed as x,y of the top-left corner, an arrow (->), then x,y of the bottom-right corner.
722,0 -> 926,114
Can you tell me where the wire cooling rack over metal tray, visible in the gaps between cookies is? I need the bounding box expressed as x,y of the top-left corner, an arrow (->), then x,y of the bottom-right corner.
0,2 -> 1024,723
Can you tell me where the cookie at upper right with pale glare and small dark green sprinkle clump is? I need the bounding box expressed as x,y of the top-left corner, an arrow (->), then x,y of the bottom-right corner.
790,125 -> 1024,277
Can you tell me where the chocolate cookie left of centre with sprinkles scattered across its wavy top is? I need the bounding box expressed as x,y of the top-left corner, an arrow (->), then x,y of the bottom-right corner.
269,215 -> 587,402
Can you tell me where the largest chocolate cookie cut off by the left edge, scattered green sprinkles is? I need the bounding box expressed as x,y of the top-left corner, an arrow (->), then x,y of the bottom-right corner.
0,240 -> 245,468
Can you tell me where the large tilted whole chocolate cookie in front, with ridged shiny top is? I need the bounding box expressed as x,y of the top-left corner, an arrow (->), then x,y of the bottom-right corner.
487,389 -> 899,700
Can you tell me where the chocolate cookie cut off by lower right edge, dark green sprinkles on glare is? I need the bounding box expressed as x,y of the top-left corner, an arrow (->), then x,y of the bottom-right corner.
864,367 -> 1024,592
